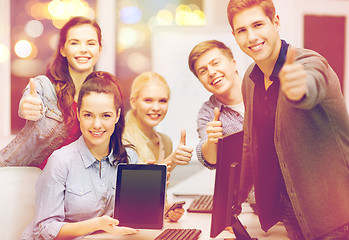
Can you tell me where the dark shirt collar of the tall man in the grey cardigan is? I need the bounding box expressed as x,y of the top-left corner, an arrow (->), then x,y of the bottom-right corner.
250,40 -> 289,83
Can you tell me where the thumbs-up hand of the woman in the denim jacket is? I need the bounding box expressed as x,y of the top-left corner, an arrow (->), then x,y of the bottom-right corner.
18,78 -> 43,121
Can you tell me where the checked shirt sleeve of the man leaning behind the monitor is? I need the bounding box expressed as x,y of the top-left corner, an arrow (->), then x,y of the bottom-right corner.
196,102 -> 216,169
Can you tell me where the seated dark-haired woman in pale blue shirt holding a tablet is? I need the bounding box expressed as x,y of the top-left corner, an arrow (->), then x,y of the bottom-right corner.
21,72 -> 138,240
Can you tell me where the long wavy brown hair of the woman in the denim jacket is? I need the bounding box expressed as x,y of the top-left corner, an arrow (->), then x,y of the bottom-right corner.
46,16 -> 102,126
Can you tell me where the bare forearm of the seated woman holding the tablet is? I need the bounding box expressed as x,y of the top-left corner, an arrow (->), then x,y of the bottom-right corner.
56,218 -> 101,239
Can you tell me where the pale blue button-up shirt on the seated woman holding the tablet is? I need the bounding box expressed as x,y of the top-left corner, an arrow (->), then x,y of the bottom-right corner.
21,136 -> 138,240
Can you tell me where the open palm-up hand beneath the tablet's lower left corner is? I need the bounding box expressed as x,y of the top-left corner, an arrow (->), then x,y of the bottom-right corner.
99,215 -> 138,235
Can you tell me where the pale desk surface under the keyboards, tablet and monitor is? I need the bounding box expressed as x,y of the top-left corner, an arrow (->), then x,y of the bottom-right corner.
84,169 -> 289,240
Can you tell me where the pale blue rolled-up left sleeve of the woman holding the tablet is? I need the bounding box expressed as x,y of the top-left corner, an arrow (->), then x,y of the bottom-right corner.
33,152 -> 69,240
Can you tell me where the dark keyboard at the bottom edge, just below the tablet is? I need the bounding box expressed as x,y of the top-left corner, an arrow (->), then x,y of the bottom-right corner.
154,228 -> 201,240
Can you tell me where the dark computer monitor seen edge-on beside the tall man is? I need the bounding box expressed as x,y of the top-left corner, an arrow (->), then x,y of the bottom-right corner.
210,131 -> 252,240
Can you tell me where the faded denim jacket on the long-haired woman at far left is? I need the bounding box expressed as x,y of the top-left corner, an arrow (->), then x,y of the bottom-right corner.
0,75 -> 69,166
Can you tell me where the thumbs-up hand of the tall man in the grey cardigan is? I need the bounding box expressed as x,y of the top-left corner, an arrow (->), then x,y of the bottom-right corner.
279,47 -> 308,101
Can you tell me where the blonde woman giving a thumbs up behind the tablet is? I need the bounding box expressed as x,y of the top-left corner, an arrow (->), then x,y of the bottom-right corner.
123,72 -> 193,221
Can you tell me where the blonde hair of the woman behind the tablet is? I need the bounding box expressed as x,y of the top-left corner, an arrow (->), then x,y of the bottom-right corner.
123,72 -> 170,163
